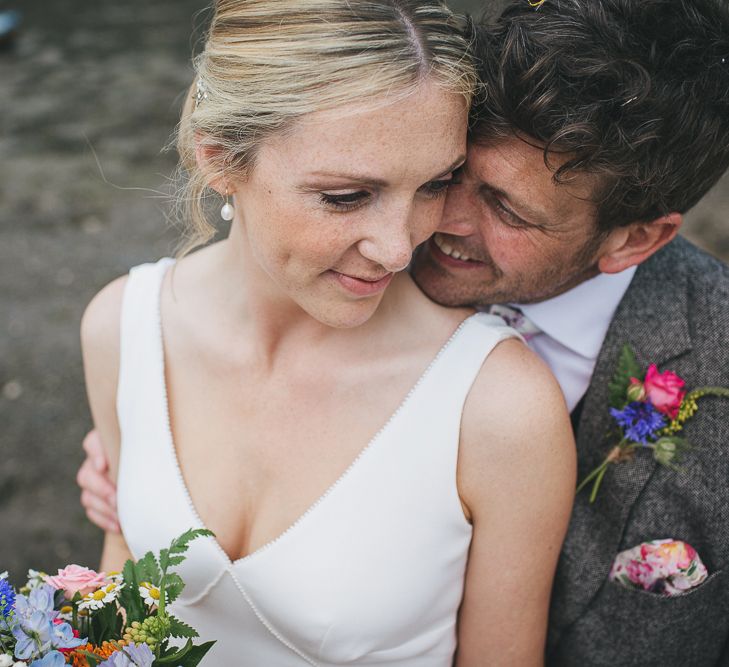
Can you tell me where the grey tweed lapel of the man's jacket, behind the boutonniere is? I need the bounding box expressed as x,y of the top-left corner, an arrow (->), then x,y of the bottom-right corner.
550,240 -> 691,646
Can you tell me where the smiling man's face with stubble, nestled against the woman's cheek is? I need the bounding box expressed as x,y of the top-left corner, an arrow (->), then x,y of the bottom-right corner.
412,138 -> 605,306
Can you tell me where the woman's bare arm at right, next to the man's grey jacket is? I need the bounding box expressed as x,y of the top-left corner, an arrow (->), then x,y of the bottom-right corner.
456,341 -> 576,667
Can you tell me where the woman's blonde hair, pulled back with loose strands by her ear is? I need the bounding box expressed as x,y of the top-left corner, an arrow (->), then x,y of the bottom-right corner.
177,0 -> 476,254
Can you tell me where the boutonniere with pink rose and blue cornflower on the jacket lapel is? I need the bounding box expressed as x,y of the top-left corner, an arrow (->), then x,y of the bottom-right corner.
577,345 -> 729,503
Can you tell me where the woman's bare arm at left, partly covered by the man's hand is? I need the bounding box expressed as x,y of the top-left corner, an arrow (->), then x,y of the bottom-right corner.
81,278 -> 131,570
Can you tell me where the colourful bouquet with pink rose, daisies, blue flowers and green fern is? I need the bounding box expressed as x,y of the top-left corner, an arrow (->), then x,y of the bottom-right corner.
0,530 -> 214,667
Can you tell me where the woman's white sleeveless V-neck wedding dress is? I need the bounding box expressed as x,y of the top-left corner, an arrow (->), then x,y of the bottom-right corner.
117,259 -> 518,667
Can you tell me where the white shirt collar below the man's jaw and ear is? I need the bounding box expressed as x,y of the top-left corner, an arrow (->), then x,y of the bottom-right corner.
513,266 -> 637,359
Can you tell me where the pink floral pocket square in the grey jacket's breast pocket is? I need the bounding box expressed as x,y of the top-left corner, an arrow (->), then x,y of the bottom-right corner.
610,539 -> 707,597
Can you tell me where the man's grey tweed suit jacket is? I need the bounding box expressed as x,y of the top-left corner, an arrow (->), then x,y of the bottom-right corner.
547,239 -> 729,667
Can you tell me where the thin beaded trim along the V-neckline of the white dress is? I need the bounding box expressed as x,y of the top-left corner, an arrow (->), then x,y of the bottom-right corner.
156,261 -> 479,567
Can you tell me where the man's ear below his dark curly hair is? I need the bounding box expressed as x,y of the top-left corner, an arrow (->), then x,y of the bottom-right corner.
597,213 -> 683,273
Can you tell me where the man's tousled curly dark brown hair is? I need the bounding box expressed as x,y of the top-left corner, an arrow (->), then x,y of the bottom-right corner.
471,0 -> 729,230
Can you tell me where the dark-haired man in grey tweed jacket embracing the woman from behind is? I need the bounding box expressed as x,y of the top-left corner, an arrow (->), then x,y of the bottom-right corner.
79,0 -> 729,667
